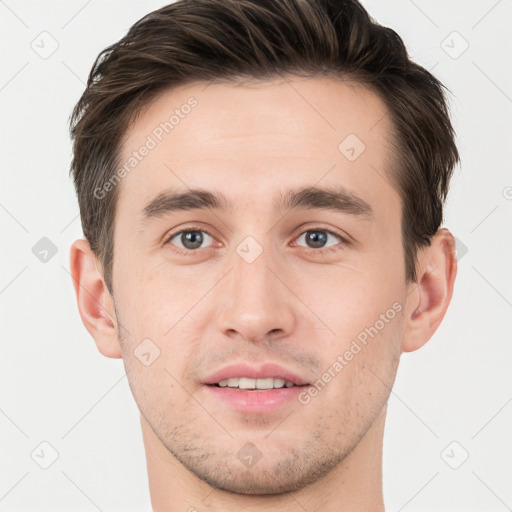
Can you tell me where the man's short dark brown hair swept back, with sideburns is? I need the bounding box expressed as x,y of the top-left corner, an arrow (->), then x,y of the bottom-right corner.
70,0 -> 459,292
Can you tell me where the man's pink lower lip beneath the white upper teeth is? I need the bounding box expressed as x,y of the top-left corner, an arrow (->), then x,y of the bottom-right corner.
205,386 -> 307,413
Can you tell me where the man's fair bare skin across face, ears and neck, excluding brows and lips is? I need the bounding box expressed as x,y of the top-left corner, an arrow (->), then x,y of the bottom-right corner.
71,77 -> 456,512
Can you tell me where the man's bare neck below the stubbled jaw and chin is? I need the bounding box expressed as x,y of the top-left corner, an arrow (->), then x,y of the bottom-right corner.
141,405 -> 387,512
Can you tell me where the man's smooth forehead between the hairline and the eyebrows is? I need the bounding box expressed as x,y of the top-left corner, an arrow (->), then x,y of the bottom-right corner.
118,78 -> 398,218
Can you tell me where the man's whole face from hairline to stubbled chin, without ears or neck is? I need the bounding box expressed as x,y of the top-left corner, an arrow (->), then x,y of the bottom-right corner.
113,78 -> 407,494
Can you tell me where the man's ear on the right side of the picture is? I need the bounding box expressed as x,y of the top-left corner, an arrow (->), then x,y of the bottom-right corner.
402,228 -> 457,352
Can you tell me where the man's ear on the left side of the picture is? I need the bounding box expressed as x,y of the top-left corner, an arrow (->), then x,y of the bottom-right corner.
70,240 -> 122,358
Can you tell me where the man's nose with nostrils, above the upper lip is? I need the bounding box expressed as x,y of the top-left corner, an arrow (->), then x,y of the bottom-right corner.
217,243 -> 297,343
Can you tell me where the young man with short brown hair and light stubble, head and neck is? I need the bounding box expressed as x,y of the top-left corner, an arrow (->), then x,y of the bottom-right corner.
71,0 -> 459,512
